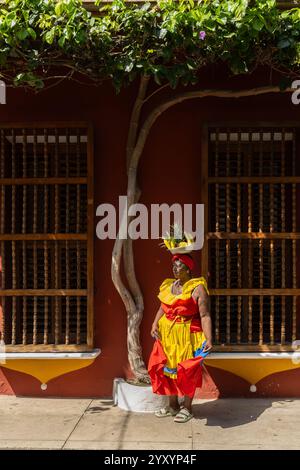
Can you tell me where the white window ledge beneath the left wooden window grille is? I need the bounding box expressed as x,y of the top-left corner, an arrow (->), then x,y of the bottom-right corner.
0,349 -> 101,362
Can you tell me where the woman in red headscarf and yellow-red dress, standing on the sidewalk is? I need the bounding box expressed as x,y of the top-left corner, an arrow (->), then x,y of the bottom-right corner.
148,254 -> 212,423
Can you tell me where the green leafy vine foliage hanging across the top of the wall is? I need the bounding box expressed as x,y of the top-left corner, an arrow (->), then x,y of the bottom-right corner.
0,0 -> 300,90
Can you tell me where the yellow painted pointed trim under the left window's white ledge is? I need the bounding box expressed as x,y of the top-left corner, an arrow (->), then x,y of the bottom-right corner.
0,358 -> 95,383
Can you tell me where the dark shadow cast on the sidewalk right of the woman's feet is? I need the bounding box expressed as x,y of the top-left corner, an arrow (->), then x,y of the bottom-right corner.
193,398 -> 293,428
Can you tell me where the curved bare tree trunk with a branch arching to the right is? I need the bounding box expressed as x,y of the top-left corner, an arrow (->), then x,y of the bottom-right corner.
111,81 -> 292,383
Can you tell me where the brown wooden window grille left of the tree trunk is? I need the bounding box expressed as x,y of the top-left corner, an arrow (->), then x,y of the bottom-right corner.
0,123 -> 93,351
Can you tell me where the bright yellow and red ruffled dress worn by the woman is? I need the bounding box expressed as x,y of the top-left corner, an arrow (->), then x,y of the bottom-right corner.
148,277 -> 208,398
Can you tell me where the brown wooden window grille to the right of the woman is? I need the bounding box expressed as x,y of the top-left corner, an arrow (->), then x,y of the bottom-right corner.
202,126 -> 300,350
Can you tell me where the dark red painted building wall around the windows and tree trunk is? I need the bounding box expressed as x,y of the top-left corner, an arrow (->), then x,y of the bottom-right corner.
0,66 -> 300,397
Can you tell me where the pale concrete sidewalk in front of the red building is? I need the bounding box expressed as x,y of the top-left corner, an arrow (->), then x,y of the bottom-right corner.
0,396 -> 300,450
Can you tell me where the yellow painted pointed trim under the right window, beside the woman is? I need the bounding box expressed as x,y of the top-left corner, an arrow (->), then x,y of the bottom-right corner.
204,358 -> 300,385
